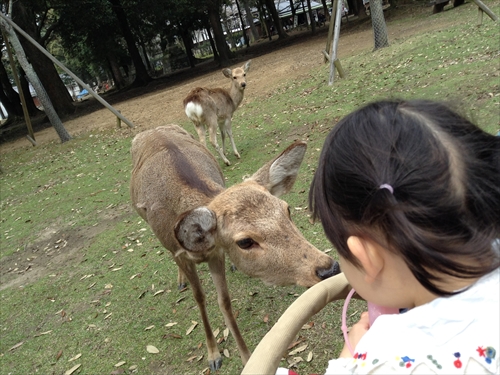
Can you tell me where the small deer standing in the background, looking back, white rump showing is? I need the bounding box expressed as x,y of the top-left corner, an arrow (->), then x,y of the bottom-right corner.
183,60 -> 251,165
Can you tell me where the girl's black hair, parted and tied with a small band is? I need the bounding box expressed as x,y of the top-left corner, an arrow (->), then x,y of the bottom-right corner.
309,100 -> 500,295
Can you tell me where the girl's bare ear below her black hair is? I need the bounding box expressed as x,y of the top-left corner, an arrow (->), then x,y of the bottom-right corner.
347,236 -> 384,283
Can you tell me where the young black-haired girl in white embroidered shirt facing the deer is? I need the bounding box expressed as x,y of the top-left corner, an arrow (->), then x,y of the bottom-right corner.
309,100 -> 500,374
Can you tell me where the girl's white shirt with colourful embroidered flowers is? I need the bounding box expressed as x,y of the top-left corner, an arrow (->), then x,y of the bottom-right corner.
326,269 -> 500,375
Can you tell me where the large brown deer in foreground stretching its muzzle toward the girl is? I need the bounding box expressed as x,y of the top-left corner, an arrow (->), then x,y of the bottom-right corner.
130,125 -> 340,371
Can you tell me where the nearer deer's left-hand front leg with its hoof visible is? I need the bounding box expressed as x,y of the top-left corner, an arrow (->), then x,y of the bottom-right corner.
176,260 -> 222,372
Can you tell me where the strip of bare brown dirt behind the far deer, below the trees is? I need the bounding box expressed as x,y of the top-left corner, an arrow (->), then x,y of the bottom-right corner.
0,4 -> 443,152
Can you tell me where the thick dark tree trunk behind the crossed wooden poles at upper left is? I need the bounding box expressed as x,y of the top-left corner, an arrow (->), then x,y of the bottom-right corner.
12,1 -> 75,115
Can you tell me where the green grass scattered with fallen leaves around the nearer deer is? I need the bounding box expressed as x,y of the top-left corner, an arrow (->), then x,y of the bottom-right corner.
0,0 -> 500,374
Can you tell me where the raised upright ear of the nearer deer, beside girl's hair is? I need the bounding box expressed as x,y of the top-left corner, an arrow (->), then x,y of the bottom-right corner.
247,141 -> 307,197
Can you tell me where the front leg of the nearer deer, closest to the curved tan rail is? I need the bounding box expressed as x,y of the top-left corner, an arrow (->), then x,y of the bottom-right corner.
208,256 -> 251,365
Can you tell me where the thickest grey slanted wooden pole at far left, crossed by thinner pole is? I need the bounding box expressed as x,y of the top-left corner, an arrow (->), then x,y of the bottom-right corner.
0,17 -> 71,143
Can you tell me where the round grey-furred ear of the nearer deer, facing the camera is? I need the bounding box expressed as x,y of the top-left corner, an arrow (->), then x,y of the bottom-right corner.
174,207 -> 217,253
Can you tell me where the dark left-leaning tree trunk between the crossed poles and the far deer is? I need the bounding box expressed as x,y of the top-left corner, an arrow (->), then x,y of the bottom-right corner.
108,0 -> 151,86
